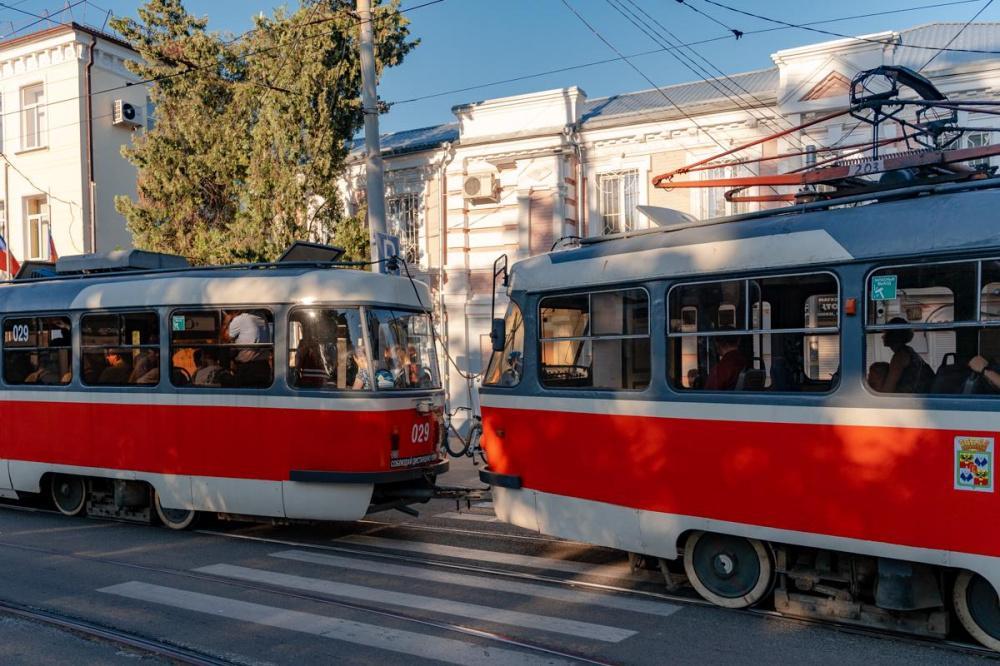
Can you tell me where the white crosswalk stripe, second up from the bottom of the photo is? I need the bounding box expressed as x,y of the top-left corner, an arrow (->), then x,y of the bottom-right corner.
196,564 -> 636,643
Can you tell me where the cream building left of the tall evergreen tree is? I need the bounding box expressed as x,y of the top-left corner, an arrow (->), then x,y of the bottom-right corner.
0,24 -> 148,271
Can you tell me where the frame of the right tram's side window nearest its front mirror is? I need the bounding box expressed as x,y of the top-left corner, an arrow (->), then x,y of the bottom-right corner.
536,285 -> 653,393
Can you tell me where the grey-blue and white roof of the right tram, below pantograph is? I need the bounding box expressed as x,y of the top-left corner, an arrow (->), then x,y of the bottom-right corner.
510,178 -> 1000,291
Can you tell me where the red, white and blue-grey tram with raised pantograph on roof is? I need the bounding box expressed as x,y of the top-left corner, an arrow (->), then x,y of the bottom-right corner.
480,68 -> 1000,650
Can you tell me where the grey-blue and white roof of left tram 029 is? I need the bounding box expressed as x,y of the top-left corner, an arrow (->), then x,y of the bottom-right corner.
0,267 -> 431,312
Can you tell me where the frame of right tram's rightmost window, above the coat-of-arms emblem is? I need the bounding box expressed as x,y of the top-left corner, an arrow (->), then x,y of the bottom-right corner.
862,256 -> 1000,399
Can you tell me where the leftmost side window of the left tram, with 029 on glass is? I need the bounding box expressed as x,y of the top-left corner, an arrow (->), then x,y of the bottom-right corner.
3,317 -> 73,386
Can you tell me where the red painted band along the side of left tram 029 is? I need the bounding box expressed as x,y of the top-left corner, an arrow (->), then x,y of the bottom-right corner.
0,401 -> 436,481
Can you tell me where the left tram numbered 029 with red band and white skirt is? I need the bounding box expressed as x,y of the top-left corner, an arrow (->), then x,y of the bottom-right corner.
0,252 -> 448,528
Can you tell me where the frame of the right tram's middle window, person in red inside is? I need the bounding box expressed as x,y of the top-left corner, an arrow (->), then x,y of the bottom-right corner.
665,270 -> 844,395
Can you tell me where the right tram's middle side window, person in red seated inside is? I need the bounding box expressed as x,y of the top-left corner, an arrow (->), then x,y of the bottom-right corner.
667,273 -> 840,392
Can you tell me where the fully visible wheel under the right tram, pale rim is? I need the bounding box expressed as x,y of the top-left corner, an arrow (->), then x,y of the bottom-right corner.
684,532 -> 774,608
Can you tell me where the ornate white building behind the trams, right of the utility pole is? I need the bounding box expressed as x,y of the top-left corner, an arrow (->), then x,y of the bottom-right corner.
344,23 -> 1000,418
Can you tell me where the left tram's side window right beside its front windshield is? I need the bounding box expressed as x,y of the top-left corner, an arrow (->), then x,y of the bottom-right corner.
288,308 -> 372,391
